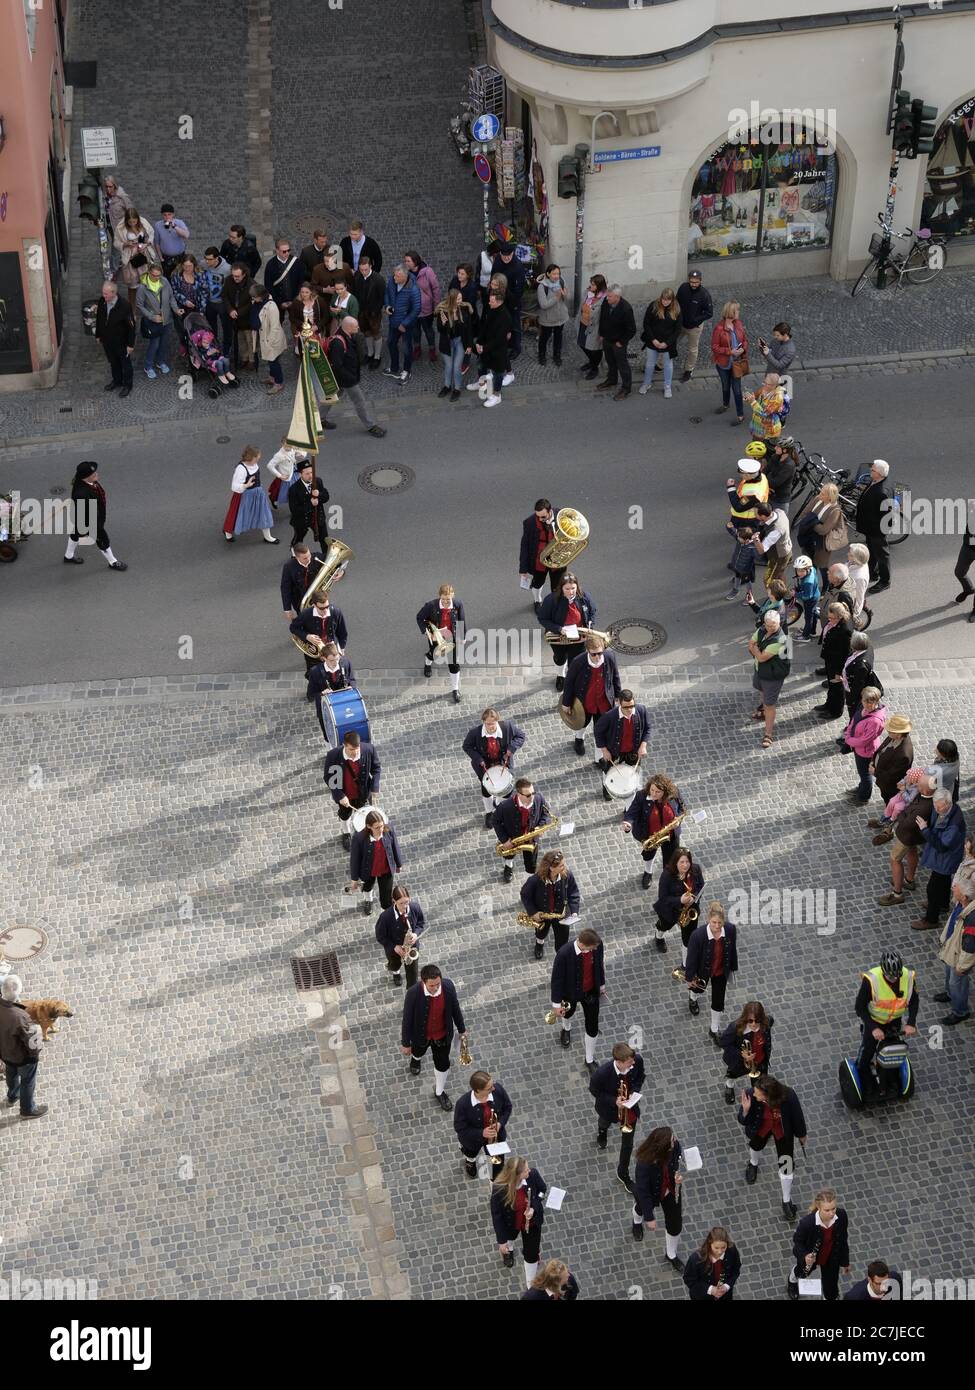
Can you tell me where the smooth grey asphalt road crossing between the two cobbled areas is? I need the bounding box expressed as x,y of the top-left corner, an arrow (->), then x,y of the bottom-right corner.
0,367 -> 975,685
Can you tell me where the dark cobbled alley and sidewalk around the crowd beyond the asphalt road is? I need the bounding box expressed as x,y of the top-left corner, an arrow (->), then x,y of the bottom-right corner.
0,0 -> 975,443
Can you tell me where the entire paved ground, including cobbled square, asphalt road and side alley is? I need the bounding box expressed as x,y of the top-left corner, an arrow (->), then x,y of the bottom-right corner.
0,0 -> 975,1301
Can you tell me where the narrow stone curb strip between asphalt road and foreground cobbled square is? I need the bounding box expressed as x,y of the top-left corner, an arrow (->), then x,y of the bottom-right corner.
0,657 -> 975,713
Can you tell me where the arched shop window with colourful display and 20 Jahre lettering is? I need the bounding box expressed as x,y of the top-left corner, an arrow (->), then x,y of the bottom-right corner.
687,143 -> 836,260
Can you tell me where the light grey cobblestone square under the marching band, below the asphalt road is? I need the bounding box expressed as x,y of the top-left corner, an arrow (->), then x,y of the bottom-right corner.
0,662 -> 975,1300
